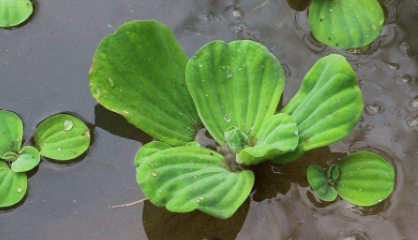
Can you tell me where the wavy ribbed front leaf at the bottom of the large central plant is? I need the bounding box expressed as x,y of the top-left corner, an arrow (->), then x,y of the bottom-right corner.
137,146 -> 254,219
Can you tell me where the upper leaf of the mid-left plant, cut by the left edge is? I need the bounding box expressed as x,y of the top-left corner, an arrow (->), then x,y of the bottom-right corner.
0,110 -> 23,158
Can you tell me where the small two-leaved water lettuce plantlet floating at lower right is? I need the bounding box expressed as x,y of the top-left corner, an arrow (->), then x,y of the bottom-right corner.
308,152 -> 395,206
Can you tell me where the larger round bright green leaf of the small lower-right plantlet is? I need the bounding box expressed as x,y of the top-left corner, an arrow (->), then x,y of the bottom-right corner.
335,152 -> 395,206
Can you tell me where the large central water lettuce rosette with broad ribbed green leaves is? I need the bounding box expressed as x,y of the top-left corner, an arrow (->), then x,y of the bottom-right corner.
89,21 -> 394,218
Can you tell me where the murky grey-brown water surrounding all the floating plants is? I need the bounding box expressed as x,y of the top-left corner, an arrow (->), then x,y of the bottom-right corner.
0,0 -> 418,240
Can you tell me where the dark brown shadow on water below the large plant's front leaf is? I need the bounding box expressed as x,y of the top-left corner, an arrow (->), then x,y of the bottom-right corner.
142,198 -> 250,240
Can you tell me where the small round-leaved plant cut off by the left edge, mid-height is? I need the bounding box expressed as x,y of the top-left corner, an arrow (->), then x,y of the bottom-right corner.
0,110 -> 90,208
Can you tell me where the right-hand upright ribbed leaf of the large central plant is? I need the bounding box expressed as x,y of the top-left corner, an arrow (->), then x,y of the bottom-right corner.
273,54 -> 363,164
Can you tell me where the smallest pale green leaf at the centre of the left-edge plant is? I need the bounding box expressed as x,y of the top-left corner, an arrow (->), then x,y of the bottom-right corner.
12,146 -> 41,172
